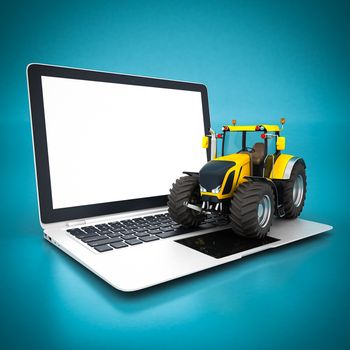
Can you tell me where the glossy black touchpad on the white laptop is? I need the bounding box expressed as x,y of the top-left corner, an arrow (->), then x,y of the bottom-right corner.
175,229 -> 279,259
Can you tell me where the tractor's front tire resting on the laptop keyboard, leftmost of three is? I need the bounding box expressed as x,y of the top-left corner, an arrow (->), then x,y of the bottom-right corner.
168,176 -> 205,227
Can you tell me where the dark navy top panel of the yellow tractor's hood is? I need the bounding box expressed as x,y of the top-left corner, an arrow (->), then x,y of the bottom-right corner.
199,160 -> 236,192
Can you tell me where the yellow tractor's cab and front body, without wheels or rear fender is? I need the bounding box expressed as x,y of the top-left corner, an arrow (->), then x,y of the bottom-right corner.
199,119 -> 285,208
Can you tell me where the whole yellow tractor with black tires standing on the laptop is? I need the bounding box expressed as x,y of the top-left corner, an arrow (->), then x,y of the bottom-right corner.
168,119 -> 306,238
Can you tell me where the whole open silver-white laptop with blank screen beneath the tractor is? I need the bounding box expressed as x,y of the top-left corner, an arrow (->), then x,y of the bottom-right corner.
27,64 -> 330,291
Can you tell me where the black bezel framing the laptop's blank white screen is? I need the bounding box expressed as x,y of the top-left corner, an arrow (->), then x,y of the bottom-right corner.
27,64 -> 210,224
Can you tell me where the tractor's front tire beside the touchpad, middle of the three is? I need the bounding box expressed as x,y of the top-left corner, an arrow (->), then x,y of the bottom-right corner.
229,181 -> 275,238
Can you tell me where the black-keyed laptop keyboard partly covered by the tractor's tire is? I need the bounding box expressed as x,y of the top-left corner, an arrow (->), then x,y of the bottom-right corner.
67,214 -> 229,253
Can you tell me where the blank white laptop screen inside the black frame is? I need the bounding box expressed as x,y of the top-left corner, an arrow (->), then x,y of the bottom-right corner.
42,76 -> 206,209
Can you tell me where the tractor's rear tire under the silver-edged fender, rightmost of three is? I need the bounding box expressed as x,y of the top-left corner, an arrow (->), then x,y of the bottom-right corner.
281,162 -> 306,219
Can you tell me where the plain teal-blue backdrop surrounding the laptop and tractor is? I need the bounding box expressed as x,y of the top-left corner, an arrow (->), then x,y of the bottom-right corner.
0,0 -> 350,349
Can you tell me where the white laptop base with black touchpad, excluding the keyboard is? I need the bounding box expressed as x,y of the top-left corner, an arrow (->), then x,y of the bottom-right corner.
44,219 -> 332,292
